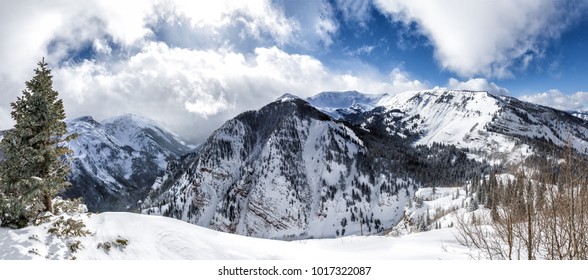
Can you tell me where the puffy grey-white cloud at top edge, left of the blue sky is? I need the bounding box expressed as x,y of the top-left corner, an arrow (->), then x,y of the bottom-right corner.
149,0 -> 301,50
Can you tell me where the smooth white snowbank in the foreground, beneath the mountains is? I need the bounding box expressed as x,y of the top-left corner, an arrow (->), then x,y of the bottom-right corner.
0,212 -> 468,260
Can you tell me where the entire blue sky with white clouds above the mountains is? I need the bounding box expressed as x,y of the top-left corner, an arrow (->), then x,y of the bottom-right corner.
0,0 -> 588,142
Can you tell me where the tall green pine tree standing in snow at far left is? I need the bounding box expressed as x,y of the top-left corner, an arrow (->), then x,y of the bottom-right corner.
0,59 -> 73,227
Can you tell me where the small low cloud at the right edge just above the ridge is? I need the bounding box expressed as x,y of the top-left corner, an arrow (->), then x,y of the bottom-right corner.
519,89 -> 588,110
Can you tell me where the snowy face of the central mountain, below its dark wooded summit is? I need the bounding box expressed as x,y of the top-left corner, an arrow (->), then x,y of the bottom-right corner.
142,103 -> 414,240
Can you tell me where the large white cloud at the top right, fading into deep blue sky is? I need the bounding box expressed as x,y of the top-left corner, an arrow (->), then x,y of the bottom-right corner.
376,0 -> 586,78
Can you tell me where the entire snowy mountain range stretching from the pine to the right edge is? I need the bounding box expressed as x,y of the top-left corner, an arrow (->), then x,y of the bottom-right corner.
1,90 -> 588,240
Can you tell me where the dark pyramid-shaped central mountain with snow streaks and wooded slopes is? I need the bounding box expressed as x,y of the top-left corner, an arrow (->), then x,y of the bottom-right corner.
141,92 -> 490,239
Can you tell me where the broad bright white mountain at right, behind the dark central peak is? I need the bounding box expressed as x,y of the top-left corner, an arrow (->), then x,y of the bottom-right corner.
317,90 -> 588,163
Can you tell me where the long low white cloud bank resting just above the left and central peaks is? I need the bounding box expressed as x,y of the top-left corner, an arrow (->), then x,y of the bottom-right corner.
48,43 -> 425,140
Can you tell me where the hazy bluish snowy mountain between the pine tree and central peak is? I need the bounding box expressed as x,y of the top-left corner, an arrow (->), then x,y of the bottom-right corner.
64,115 -> 191,212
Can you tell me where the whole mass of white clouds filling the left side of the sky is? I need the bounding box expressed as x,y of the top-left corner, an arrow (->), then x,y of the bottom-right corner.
0,0 -> 426,141
